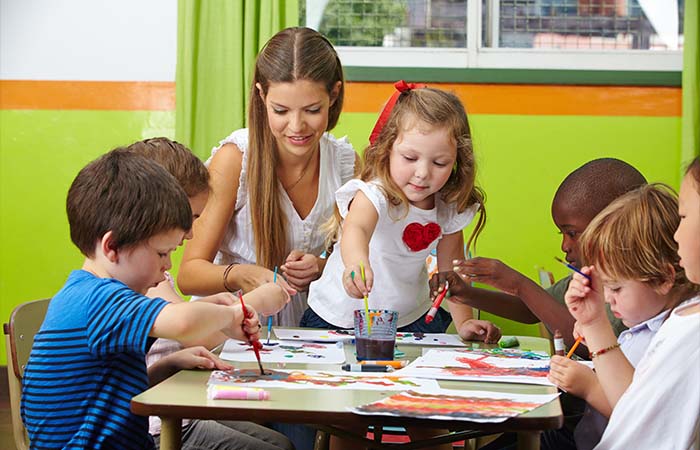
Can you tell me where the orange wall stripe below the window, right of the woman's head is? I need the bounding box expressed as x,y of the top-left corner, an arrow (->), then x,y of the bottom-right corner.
343,82 -> 681,117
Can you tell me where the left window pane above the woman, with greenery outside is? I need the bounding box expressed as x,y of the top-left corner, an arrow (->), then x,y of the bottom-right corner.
300,0 -> 467,48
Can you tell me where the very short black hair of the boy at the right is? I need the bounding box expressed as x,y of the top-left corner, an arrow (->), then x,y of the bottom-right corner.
553,158 -> 647,220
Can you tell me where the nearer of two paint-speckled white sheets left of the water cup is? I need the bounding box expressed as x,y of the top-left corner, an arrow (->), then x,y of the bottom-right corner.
220,339 -> 345,364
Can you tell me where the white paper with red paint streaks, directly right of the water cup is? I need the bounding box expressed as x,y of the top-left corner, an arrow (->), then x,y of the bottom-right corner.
396,349 -> 553,386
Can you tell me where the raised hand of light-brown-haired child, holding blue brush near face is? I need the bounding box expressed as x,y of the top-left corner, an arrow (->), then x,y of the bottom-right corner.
564,266 -> 607,329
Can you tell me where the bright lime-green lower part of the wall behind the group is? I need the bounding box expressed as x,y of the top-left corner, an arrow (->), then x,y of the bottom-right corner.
0,110 -> 680,364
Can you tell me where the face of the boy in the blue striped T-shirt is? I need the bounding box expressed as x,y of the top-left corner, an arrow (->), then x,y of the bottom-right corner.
111,229 -> 185,294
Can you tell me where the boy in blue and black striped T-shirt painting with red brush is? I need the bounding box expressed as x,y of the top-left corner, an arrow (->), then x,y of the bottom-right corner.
21,149 -> 260,449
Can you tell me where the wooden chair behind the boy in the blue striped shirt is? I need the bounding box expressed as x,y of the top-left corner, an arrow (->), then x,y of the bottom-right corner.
3,299 -> 50,450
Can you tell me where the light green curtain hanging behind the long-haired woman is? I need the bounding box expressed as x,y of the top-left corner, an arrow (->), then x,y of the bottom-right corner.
175,0 -> 299,158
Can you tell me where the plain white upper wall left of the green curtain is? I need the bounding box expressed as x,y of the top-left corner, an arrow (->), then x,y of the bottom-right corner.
0,0 -> 177,81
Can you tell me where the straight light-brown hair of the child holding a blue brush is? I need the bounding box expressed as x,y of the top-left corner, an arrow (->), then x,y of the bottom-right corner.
579,183 -> 698,303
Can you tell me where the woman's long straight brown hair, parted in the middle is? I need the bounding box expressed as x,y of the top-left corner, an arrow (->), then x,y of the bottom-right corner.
247,27 -> 345,269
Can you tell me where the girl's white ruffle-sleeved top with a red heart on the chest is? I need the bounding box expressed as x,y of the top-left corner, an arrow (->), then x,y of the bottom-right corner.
308,179 -> 479,328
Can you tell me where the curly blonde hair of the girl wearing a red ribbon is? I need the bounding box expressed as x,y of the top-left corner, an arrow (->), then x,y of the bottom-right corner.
360,87 -> 486,248
